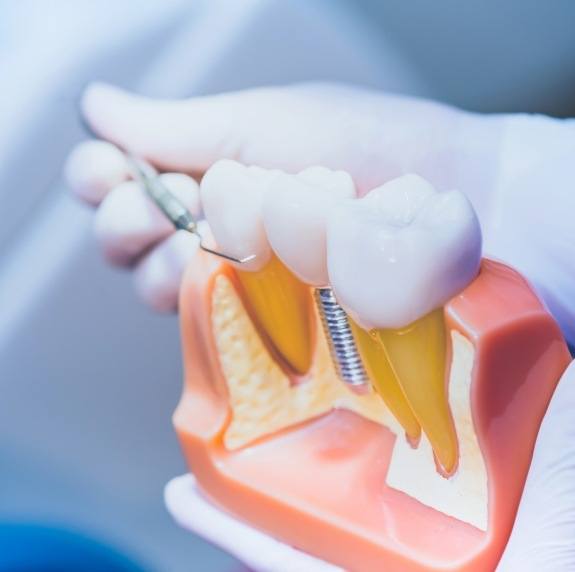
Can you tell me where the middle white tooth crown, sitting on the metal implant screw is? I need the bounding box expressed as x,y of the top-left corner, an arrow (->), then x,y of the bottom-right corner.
264,167 -> 355,286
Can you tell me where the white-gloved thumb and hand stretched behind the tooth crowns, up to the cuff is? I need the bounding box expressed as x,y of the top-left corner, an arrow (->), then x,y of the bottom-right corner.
82,83 -> 498,194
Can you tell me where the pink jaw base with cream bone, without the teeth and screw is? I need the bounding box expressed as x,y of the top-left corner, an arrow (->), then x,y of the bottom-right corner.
175,255 -> 569,572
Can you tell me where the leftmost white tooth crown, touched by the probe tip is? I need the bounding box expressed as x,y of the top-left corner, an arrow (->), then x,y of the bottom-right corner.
200,160 -> 277,270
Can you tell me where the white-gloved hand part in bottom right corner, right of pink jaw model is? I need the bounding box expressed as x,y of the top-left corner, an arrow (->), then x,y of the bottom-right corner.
498,362 -> 575,572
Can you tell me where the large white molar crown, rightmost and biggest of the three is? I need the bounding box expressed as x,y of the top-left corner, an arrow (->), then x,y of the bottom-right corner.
327,175 -> 481,330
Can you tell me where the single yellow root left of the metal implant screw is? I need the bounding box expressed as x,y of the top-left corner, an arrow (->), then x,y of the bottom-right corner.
236,256 -> 313,375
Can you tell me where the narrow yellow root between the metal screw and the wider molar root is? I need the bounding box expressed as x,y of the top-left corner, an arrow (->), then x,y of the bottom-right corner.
348,318 -> 421,444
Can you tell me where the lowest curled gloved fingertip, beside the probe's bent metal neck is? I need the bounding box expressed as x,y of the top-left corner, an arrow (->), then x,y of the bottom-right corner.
134,231 -> 199,312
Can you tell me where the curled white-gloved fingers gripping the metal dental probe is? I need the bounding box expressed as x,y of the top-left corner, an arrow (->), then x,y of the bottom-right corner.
66,141 -> 201,311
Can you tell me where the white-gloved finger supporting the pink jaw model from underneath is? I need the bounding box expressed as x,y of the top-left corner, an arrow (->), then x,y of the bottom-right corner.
164,475 -> 342,572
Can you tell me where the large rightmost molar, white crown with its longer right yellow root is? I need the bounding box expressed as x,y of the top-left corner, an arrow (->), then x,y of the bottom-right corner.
327,175 -> 481,475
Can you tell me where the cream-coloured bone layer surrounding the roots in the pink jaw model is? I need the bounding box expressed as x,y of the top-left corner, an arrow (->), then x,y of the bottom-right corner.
208,256 -> 488,530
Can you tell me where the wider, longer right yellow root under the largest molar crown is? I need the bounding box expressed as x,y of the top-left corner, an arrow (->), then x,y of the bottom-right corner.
376,308 -> 458,475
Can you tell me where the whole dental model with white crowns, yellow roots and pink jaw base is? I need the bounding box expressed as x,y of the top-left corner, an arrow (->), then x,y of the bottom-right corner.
174,161 -> 570,572
